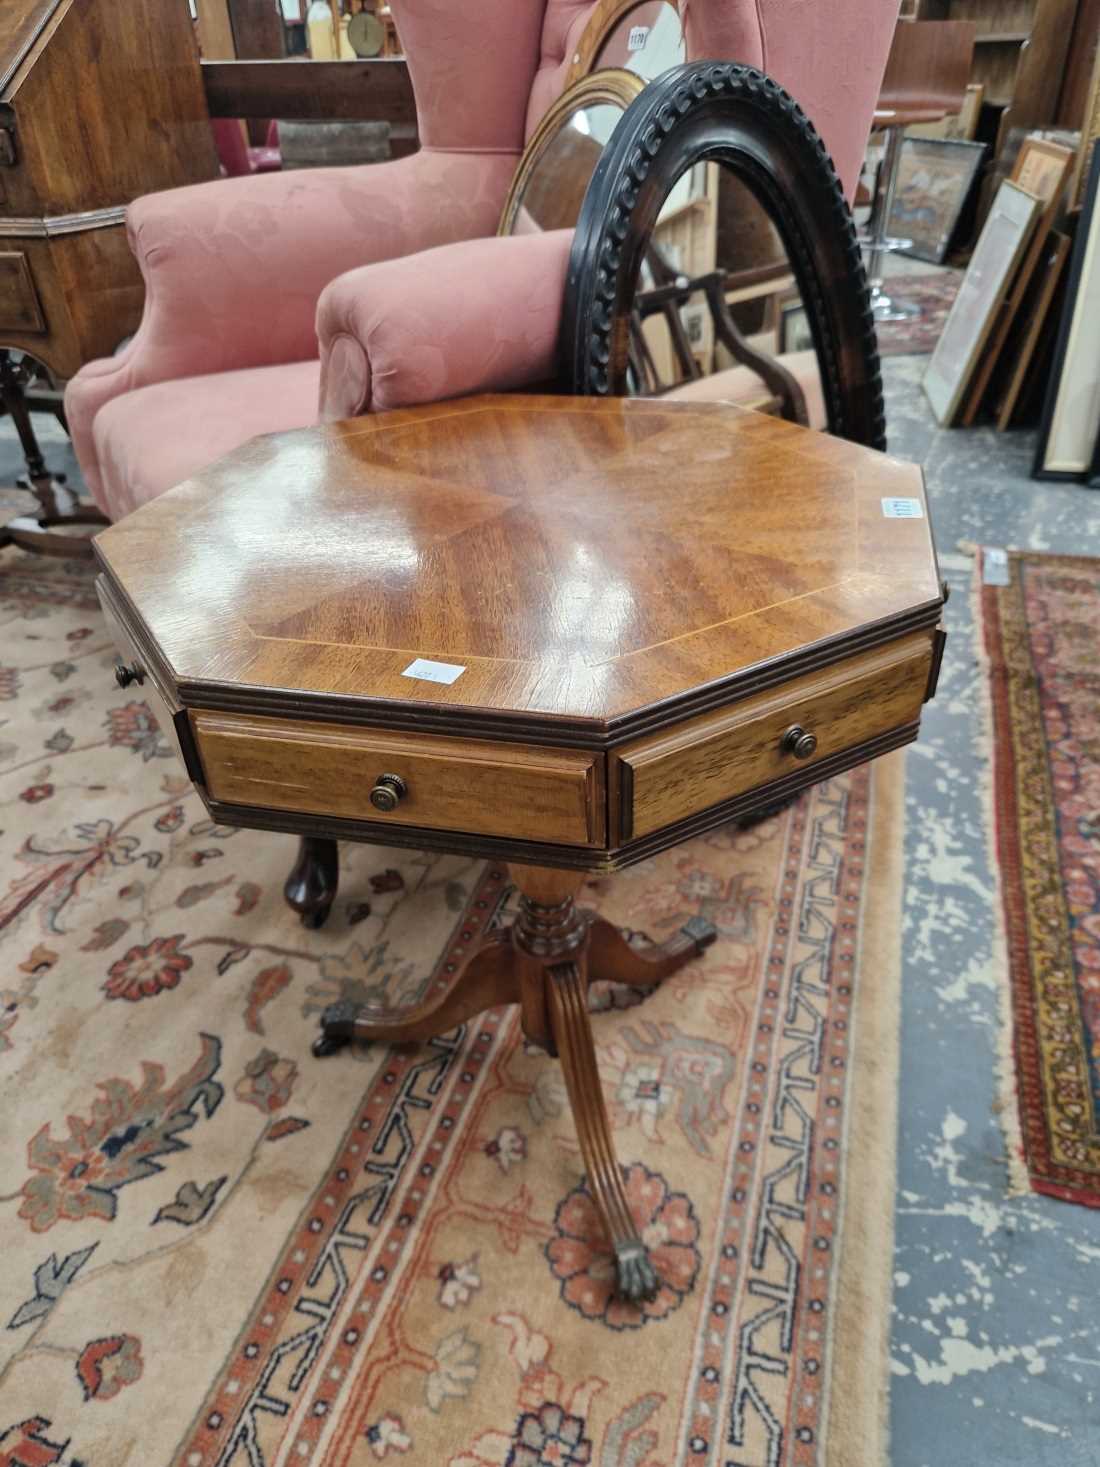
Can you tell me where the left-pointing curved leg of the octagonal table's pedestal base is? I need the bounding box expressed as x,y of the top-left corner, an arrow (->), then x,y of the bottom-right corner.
314,932 -> 519,1058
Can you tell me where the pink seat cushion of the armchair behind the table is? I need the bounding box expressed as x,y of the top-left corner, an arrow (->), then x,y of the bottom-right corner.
92,361 -> 321,519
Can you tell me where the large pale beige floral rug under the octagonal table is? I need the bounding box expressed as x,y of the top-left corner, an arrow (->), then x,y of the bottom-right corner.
0,552 -> 902,1467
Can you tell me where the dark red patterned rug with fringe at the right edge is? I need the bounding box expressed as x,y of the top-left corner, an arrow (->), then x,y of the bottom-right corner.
980,552 -> 1100,1207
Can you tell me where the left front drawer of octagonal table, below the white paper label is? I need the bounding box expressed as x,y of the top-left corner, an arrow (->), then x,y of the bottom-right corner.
191,709 -> 604,845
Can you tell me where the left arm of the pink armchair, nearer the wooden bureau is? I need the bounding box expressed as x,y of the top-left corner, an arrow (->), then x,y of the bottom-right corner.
66,148 -> 515,489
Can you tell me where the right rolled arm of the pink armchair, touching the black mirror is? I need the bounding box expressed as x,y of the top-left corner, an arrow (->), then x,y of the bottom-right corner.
317,229 -> 573,421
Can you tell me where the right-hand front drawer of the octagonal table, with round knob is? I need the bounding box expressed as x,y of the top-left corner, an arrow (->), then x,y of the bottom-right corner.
610,632 -> 933,841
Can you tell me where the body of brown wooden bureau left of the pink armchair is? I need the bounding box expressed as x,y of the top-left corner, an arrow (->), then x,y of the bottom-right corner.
0,0 -> 219,380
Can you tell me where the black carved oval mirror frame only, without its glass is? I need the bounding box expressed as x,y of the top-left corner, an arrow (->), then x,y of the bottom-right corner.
560,62 -> 886,449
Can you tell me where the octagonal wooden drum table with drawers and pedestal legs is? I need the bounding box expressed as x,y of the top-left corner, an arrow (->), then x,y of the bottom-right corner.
95,396 -> 943,1298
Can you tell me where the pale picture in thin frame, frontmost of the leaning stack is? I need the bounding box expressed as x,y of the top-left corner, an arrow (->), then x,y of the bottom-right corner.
924,179 -> 1041,425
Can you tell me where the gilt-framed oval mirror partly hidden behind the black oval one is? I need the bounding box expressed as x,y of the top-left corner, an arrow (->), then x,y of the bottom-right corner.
497,70 -> 645,235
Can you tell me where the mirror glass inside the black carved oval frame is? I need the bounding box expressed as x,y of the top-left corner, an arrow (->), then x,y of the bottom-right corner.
625,163 -> 826,428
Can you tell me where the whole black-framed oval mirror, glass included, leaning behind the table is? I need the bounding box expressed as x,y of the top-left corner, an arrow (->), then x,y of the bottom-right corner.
562,62 -> 884,447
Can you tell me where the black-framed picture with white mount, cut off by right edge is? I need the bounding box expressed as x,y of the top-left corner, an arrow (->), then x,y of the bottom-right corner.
1034,148 -> 1100,480
